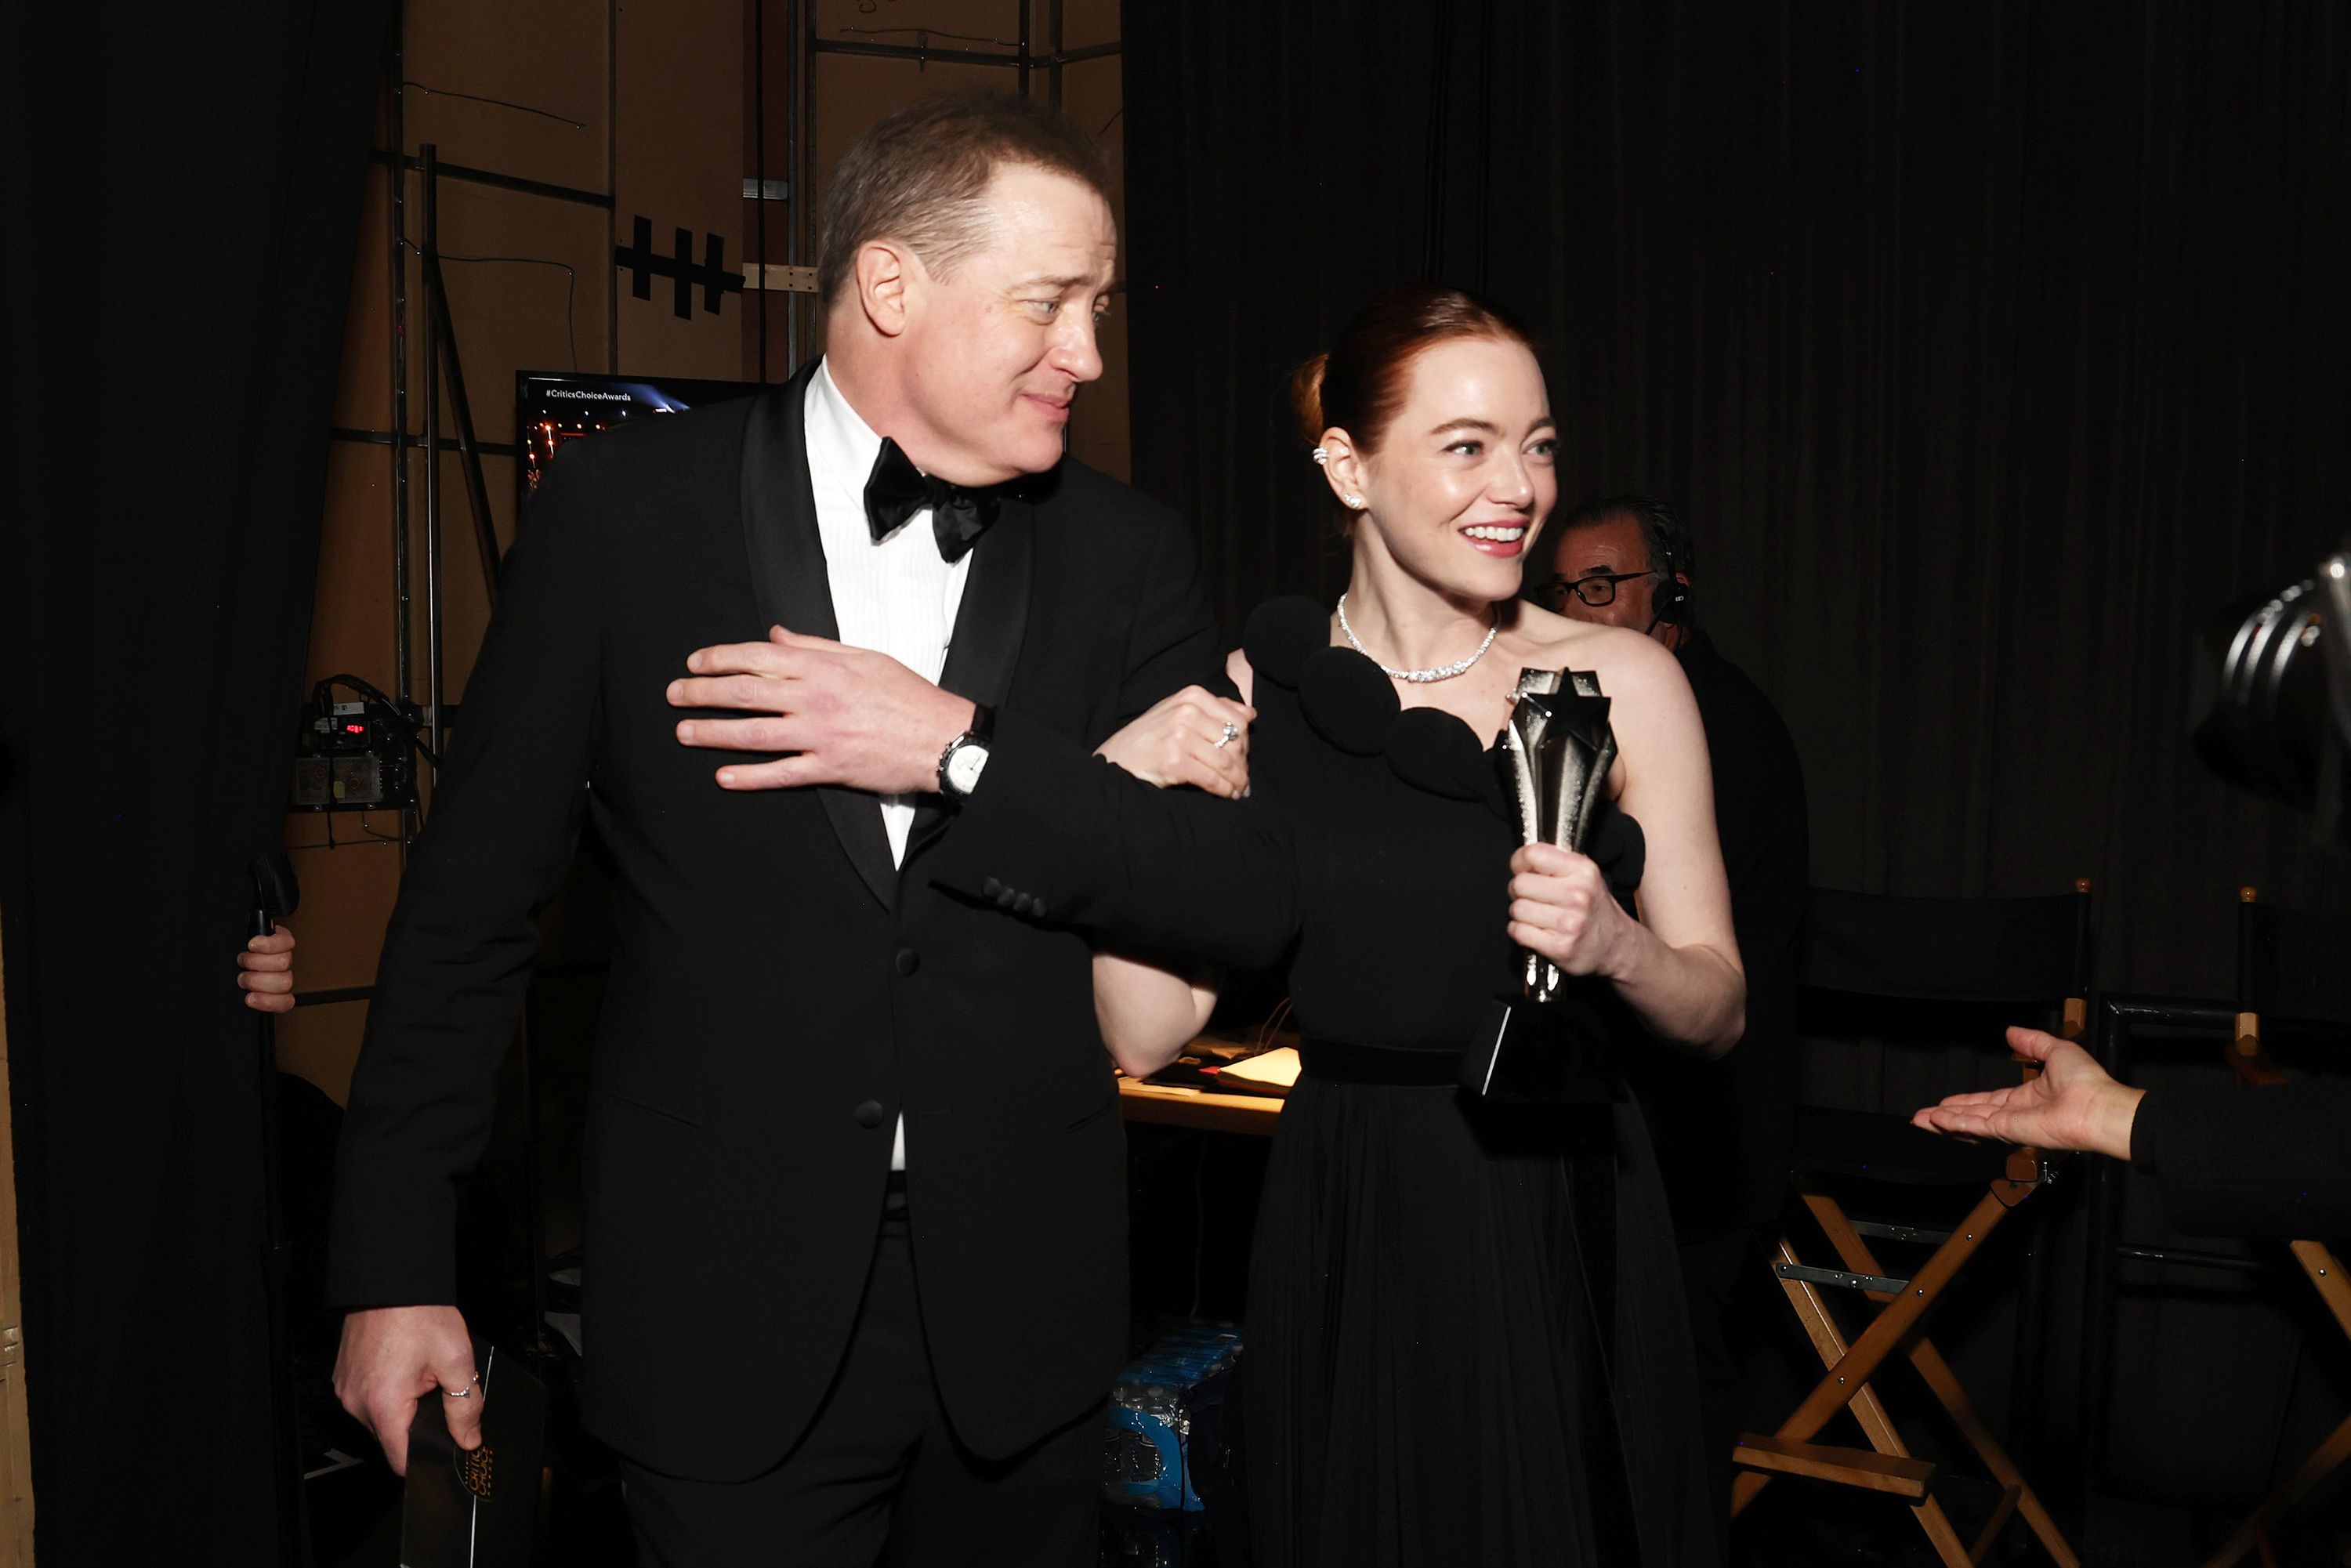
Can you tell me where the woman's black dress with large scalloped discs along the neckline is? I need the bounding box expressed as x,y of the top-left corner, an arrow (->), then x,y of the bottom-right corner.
1241,599 -> 1714,1568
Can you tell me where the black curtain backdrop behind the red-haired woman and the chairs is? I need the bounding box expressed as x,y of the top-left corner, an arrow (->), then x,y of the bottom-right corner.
1124,0 -> 2351,992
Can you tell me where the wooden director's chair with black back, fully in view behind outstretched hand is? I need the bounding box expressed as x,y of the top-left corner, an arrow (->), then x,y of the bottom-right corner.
1730,882 -> 2092,1568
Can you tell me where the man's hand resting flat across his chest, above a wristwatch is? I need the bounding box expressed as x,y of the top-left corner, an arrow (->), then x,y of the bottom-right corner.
670,625 -> 973,795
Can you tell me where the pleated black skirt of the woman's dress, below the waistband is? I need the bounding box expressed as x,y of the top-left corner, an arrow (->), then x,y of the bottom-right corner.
1241,1072 -> 1625,1568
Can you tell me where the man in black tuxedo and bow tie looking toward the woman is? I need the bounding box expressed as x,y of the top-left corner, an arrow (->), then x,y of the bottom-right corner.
331,99 -> 1239,1568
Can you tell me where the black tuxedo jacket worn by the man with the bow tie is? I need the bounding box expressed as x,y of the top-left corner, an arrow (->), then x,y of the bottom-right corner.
329,367 -> 1218,1481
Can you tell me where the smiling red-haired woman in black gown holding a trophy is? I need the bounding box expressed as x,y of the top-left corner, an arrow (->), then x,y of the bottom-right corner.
1096,287 -> 1744,1568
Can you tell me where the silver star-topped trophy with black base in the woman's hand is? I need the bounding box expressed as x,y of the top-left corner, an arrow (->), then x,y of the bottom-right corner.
1460,670 -> 1615,1100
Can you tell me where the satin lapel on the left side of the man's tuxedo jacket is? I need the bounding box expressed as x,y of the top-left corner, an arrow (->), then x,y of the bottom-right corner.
743,364 -> 898,910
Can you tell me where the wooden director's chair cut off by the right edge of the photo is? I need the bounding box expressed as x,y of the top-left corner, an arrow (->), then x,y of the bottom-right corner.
2205,889 -> 2351,1568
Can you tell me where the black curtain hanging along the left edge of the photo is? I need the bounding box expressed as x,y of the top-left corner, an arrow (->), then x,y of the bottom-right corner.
0,0 -> 390,1566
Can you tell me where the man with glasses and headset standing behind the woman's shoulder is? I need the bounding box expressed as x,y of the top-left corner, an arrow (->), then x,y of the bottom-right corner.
1526,496 -> 1810,1540
